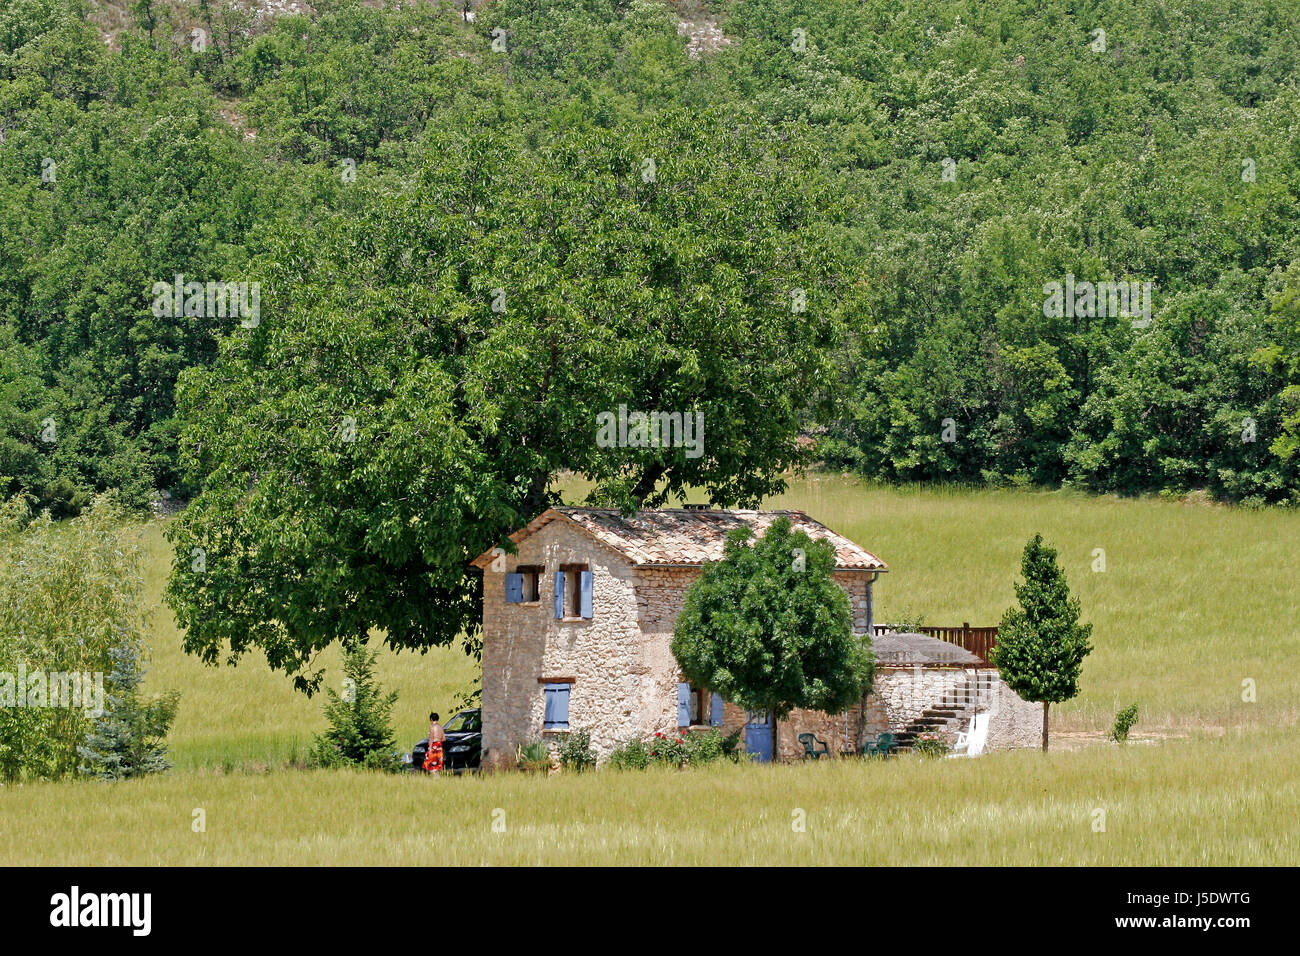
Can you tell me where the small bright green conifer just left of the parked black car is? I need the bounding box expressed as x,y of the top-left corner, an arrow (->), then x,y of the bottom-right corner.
315,644 -> 398,769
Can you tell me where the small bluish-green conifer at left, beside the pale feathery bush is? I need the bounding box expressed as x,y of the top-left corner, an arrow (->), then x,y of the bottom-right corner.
77,639 -> 181,780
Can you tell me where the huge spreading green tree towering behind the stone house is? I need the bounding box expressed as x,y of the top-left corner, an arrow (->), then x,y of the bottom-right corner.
168,109 -> 854,691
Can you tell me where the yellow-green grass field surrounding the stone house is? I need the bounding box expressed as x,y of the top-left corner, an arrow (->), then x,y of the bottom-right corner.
0,476 -> 1300,865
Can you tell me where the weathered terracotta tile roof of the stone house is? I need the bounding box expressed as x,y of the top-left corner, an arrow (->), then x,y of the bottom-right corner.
473,507 -> 889,571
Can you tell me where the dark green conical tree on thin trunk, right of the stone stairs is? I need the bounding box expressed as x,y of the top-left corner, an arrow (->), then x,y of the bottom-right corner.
992,535 -> 1092,750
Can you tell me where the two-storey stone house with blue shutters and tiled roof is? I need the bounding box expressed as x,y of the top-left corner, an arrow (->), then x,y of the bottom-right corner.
473,507 -> 1041,765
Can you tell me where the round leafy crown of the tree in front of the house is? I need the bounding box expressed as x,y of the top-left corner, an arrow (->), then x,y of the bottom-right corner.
672,515 -> 872,718
